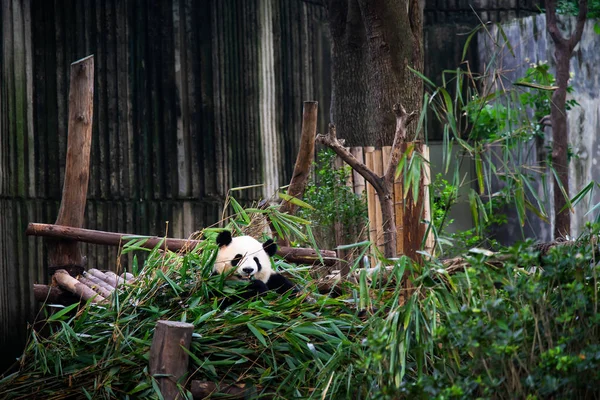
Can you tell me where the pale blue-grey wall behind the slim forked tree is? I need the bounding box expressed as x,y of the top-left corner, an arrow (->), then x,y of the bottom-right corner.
479,15 -> 600,243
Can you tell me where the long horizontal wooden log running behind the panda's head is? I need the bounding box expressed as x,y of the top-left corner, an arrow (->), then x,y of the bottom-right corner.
25,223 -> 336,265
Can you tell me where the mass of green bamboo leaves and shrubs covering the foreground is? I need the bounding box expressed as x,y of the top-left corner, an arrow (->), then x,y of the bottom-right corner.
0,208 -> 600,399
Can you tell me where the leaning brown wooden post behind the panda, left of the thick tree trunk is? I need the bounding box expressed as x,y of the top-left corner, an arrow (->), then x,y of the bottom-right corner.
280,101 -> 319,214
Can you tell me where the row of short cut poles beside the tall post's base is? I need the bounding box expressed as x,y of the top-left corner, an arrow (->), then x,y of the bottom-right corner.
33,268 -> 133,304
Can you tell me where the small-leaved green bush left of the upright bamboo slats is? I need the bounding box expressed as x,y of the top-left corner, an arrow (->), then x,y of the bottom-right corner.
298,149 -> 367,248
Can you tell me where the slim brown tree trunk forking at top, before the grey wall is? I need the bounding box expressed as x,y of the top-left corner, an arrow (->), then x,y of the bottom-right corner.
545,0 -> 587,238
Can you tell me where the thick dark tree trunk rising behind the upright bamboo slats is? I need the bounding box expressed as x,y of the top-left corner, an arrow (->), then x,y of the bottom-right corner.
325,0 -> 423,147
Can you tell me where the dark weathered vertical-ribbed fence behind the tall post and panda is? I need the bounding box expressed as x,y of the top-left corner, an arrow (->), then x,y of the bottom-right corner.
0,0 -> 330,368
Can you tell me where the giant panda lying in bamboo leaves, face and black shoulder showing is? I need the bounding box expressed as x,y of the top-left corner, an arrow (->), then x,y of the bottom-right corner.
213,231 -> 295,304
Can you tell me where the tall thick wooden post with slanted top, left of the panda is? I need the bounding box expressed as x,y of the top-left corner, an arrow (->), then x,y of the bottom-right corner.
48,56 -> 94,275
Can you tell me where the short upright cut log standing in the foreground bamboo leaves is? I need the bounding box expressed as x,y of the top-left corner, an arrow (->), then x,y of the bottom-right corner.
149,321 -> 194,400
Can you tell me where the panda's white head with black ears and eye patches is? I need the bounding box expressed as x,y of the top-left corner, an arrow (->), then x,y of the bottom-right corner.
214,231 -> 277,283
